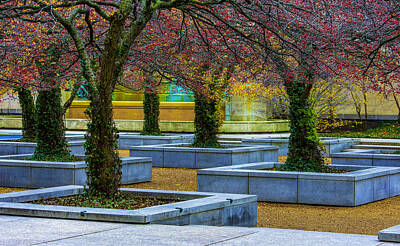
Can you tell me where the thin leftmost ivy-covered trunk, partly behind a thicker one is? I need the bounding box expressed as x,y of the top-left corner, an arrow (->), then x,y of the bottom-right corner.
16,87 -> 36,142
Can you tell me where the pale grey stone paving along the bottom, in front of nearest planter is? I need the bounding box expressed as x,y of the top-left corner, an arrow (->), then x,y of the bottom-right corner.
0,215 -> 399,246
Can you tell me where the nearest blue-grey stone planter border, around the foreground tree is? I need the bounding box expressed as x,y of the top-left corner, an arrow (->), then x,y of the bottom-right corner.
0,185 -> 257,226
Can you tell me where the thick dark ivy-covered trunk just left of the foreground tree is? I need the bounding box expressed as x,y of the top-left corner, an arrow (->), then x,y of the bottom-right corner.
33,88 -> 70,160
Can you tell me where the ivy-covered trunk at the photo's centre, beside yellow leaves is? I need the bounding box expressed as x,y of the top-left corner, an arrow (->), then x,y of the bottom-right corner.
193,92 -> 220,148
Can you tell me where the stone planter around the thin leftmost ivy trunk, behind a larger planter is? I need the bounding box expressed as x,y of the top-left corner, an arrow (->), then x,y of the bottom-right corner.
0,141 -> 85,155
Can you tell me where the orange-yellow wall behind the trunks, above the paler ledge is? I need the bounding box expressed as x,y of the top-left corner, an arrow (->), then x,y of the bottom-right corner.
66,101 -> 194,121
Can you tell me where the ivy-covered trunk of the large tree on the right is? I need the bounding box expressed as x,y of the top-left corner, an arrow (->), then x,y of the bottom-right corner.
282,66 -> 324,172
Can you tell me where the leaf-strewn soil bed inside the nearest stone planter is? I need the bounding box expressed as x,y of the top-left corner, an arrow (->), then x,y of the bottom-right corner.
28,193 -> 183,210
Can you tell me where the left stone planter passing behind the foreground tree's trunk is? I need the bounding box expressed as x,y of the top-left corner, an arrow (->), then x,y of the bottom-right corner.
0,154 -> 152,188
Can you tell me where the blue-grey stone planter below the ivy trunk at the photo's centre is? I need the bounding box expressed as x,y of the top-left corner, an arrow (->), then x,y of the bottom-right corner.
130,144 -> 278,169
